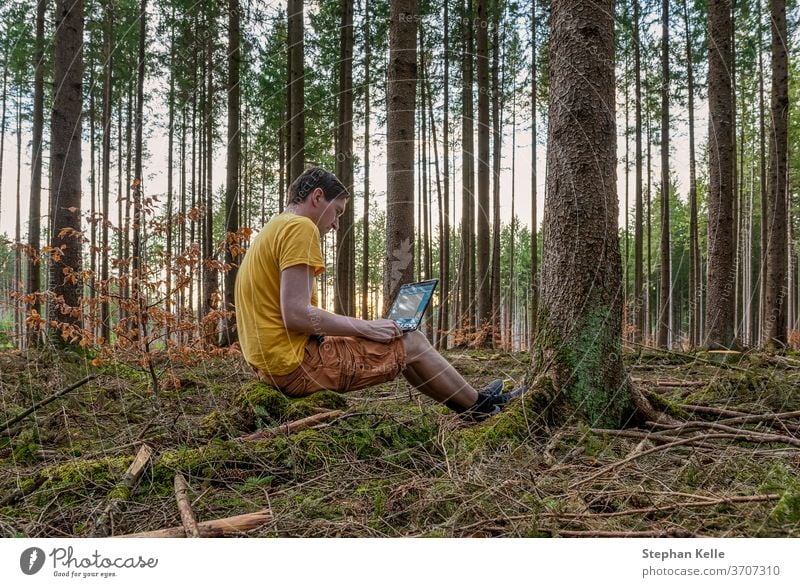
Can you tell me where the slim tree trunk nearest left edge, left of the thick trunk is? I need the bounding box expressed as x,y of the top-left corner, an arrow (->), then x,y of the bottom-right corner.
26,0 -> 47,346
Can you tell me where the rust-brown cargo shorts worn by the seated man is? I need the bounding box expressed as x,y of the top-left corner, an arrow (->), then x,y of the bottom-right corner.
257,336 -> 406,397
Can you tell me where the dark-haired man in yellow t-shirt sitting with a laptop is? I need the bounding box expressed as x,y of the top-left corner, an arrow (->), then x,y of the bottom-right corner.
235,167 -> 510,420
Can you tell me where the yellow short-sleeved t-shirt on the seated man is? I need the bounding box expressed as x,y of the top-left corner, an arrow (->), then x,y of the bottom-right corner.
235,212 -> 325,375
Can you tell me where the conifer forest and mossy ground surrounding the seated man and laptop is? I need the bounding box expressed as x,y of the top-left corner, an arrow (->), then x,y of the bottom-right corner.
0,0 -> 800,536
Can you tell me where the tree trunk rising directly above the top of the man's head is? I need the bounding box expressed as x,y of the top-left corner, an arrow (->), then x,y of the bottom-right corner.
287,0 -> 306,185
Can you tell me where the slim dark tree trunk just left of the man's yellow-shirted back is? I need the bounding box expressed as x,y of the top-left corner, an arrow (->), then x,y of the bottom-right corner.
223,0 -> 242,345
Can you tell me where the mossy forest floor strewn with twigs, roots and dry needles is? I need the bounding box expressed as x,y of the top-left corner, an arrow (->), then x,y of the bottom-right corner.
0,350 -> 800,537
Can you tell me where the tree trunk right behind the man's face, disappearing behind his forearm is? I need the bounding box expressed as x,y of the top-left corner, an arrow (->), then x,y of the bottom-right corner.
334,0 -> 356,316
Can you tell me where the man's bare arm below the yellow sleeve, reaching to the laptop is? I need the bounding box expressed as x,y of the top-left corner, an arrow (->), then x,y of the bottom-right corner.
281,265 -> 403,342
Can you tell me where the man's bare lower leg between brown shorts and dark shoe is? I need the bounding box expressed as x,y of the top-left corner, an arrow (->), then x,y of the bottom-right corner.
403,331 -> 478,408
